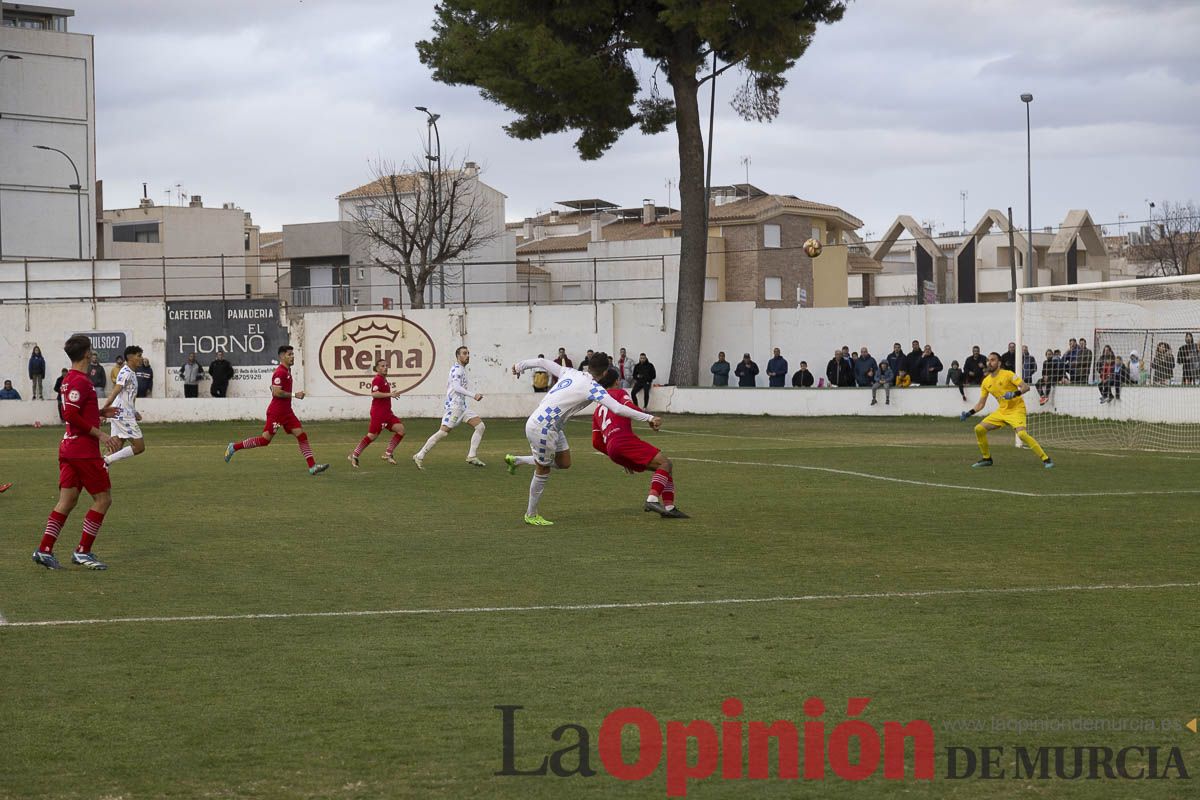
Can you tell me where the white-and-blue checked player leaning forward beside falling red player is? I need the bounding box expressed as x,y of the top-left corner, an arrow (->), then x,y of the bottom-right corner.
504,353 -> 662,525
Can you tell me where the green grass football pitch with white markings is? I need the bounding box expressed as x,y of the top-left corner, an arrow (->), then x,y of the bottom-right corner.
0,416 -> 1200,800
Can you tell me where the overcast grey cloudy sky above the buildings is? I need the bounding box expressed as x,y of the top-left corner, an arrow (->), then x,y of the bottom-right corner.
75,0 -> 1200,236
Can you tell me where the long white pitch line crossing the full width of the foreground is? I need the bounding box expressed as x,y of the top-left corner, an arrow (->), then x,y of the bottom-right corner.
5,582 -> 1200,627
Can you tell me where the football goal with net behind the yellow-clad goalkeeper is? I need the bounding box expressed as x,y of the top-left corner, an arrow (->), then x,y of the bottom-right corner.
1016,275 -> 1200,452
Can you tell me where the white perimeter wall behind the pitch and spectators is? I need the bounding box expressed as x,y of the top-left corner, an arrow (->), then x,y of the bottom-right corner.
0,302 -> 1200,425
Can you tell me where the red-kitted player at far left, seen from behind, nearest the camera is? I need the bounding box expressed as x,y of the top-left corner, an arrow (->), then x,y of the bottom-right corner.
34,333 -> 120,570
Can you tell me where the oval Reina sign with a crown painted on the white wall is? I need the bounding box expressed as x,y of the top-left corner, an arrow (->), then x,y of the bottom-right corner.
320,314 -> 434,397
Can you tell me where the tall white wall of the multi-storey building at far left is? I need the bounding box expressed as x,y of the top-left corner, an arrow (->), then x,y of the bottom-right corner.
0,28 -> 96,259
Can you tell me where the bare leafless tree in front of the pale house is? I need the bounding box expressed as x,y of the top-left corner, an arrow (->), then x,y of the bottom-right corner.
349,157 -> 499,308
